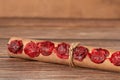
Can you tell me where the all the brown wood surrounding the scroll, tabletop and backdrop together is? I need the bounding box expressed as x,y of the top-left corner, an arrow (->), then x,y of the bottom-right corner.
0,0 -> 120,80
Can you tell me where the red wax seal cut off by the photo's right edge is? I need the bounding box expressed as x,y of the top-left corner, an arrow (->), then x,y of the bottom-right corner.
110,51 -> 120,66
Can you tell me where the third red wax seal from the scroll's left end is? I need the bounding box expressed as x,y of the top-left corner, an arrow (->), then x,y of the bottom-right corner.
37,41 -> 54,56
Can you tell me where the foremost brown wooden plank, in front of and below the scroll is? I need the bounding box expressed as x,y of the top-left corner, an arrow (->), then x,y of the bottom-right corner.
0,58 -> 120,80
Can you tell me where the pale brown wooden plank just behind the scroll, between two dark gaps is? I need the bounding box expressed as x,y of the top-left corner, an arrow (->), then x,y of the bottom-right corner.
0,25 -> 120,40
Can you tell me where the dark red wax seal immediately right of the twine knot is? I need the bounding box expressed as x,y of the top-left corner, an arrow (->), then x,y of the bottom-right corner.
73,46 -> 89,61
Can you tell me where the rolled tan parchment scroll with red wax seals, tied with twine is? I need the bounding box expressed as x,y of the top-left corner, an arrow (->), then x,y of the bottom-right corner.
7,37 -> 120,72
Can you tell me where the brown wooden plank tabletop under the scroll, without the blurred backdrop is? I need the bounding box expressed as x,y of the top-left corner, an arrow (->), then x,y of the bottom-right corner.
0,20 -> 120,80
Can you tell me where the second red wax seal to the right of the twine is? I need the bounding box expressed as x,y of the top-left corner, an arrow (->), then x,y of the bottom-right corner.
89,48 -> 109,64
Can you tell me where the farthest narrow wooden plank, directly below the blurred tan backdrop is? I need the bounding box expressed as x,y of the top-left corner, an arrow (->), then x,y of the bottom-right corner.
0,18 -> 120,27
